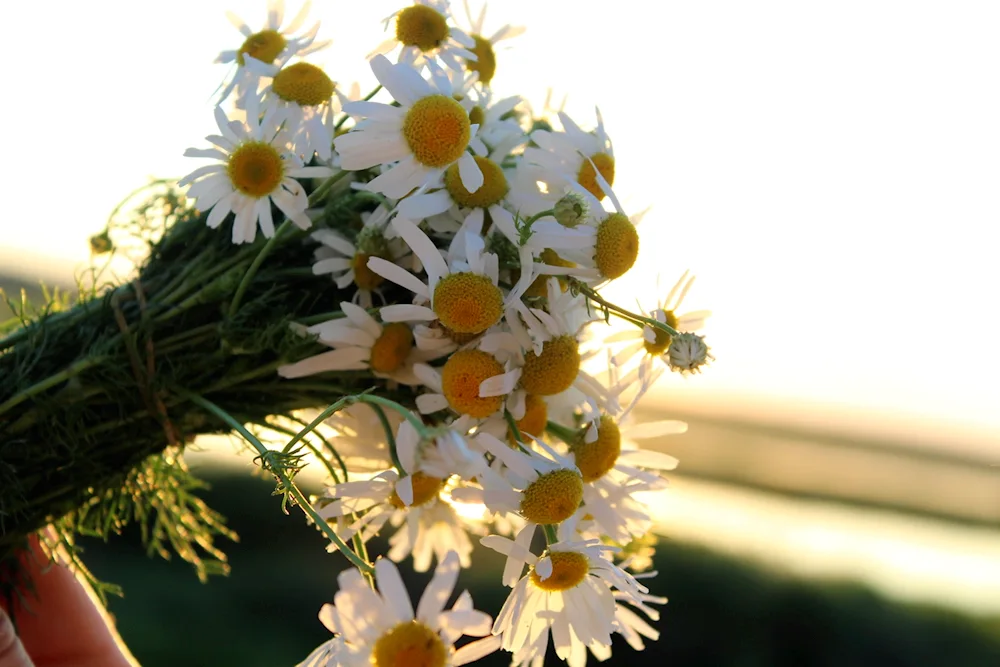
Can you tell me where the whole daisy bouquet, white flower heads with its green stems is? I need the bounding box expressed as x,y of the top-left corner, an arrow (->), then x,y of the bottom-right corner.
0,0 -> 711,667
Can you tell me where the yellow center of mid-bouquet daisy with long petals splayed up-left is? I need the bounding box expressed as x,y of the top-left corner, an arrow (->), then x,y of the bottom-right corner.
434,273 -> 503,334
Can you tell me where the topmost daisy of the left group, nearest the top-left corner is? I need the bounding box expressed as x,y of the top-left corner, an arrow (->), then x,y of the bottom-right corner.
215,0 -> 330,104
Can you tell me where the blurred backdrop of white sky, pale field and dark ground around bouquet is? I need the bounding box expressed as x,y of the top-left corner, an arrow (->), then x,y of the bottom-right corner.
0,0 -> 1000,666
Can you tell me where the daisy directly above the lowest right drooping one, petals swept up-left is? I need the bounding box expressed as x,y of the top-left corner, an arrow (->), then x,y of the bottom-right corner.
452,433 -> 583,524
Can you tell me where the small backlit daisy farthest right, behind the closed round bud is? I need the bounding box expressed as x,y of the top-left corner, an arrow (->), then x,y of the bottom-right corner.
604,271 -> 712,373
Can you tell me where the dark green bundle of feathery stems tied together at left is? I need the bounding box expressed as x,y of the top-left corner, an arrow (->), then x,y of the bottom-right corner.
0,180 -> 413,596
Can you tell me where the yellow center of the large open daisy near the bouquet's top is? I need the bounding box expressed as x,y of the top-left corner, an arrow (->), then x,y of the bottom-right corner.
403,95 -> 472,167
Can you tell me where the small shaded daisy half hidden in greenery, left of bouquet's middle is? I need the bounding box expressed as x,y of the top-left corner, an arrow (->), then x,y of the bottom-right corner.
312,204 -> 414,308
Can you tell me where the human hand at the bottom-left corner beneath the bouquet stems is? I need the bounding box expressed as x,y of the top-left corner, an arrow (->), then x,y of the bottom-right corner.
0,537 -> 138,667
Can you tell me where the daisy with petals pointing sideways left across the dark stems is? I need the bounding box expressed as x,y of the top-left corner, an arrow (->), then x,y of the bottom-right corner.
278,301 -> 442,385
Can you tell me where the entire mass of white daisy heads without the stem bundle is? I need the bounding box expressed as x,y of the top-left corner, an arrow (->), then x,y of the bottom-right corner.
182,0 -> 711,667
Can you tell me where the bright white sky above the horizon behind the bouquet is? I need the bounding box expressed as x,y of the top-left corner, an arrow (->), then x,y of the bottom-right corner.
0,0 -> 1000,444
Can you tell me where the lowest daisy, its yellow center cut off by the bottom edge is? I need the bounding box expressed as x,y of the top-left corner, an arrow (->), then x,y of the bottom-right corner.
302,553 -> 499,667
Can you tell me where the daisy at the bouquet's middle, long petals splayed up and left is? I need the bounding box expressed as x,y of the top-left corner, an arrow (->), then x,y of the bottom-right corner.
368,216 -> 531,335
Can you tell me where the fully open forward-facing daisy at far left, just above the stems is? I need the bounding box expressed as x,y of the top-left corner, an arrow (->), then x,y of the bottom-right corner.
178,107 -> 333,243
